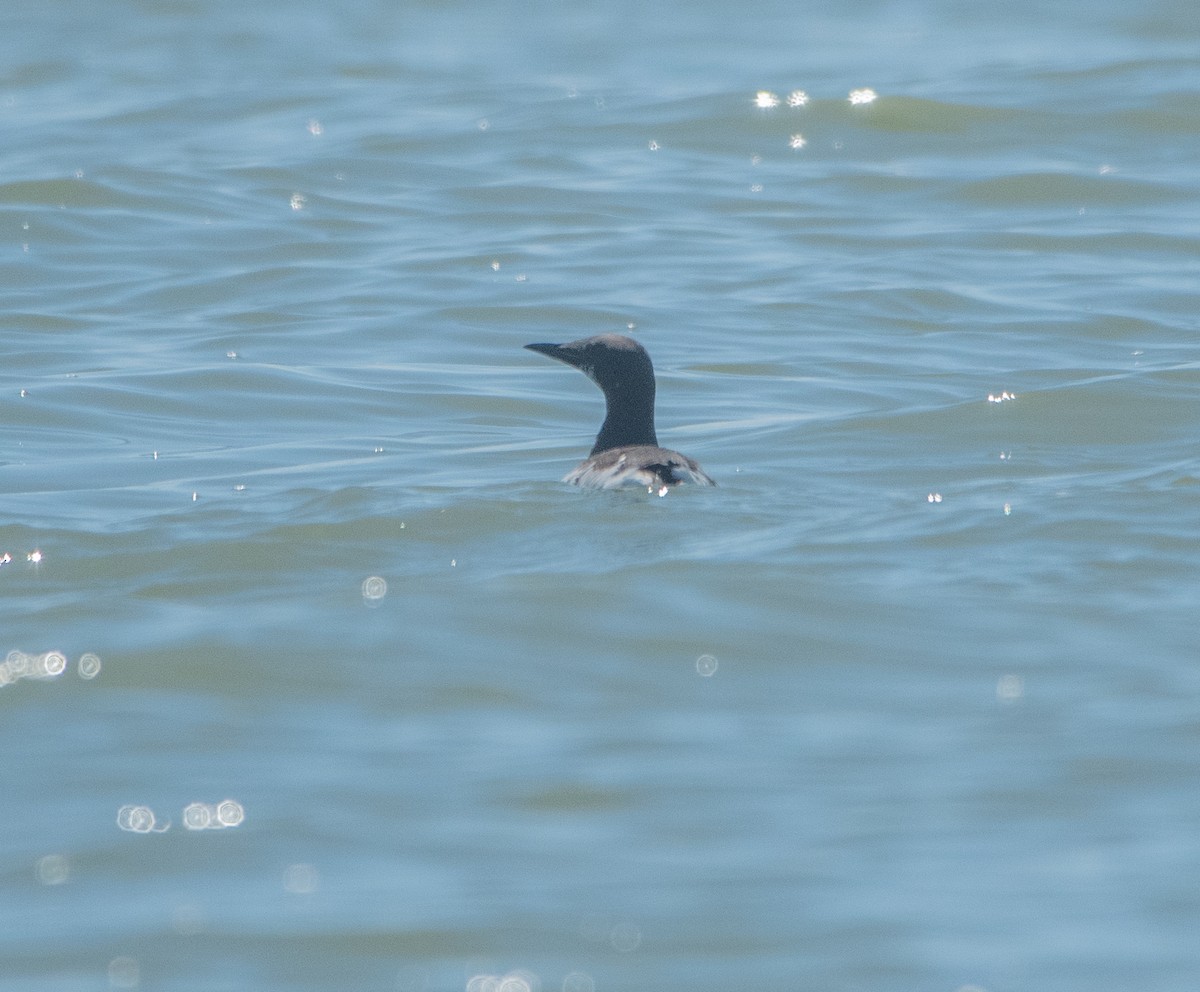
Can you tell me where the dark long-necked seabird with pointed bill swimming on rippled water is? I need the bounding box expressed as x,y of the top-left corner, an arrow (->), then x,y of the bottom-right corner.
524,333 -> 716,495
